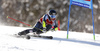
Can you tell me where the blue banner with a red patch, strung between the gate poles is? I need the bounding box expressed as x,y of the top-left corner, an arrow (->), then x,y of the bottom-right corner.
71,0 -> 93,9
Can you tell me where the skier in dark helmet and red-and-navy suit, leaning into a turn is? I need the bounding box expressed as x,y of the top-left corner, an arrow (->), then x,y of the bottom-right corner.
18,9 -> 58,36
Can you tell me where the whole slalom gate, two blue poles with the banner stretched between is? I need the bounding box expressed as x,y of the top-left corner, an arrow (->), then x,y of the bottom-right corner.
67,0 -> 95,40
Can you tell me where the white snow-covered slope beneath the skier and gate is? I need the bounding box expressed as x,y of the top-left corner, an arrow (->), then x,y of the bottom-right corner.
0,26 -> 100,51
